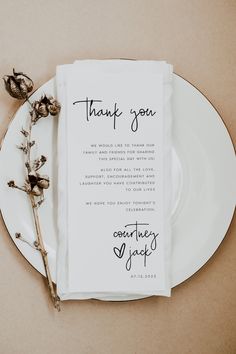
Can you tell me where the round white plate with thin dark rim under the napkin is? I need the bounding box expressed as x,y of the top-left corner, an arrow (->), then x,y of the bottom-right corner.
0,75 -> 236,299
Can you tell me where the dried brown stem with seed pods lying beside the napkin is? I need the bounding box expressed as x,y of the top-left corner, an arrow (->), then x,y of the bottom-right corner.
3,69 -> 60,311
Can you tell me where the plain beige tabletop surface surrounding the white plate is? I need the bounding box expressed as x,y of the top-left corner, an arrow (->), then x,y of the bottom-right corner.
0,0 -> 236,354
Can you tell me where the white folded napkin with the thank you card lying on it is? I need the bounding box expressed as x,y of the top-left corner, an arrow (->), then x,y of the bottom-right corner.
56,60 -> 172,300
